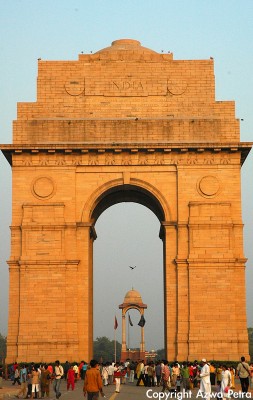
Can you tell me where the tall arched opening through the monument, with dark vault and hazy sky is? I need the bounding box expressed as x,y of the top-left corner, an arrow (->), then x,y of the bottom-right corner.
93,202 -> 165,361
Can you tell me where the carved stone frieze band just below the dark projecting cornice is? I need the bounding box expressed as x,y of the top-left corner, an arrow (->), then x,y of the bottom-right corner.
12,149 -> 235,167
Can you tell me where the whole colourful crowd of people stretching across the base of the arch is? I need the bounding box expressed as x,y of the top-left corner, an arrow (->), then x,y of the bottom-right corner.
0,357 -> 253,400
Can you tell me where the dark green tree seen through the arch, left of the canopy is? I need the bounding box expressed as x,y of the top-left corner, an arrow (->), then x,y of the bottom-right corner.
93,336 -> 121,362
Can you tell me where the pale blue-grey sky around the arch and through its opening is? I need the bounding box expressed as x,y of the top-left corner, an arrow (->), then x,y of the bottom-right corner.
0,0 -> 253,350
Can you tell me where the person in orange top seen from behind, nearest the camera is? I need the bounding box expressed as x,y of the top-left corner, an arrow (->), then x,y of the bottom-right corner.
83,360 -> 105,400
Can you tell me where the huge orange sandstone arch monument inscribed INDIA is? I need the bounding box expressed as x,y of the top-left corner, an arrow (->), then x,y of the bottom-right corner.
1,39 -> 251,362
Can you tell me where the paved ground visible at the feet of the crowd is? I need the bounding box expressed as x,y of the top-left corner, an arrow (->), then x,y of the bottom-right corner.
0,381 -> 253,400
